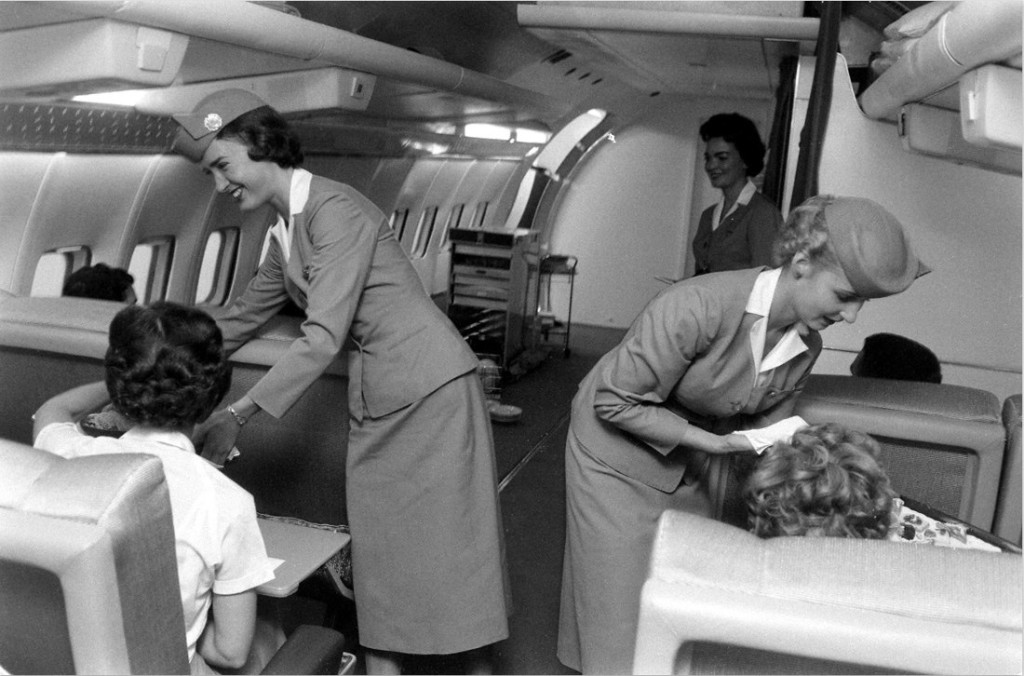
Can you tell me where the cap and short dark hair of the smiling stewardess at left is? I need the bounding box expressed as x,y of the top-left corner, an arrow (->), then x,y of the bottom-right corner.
167,89 -> 302,169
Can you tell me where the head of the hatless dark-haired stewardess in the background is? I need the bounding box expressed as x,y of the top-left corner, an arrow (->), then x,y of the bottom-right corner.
700,113 -> 765,187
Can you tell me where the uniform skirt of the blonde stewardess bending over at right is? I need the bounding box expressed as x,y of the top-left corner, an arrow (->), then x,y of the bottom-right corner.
558,429 -> 711,674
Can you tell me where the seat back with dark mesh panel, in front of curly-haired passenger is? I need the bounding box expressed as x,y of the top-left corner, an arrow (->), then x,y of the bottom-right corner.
796,375 -> 1006,531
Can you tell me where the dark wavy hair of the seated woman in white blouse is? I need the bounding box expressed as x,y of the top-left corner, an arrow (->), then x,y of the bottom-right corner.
105,302 -> 231,428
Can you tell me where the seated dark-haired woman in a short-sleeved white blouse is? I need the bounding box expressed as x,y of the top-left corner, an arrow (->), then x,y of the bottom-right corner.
34,302 -> 276,673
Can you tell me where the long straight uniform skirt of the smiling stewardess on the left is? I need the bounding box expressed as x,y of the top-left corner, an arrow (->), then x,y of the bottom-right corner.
346,372 -> 511,654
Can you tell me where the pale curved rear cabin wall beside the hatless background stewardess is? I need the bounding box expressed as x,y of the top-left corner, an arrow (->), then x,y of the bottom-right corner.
549,97 -> 770,328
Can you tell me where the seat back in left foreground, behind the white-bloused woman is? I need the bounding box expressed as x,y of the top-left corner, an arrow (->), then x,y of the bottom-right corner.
0,439 -> 188,674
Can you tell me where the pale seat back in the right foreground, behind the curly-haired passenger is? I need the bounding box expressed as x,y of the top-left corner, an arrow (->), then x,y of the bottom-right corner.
633,511 -> 1022,674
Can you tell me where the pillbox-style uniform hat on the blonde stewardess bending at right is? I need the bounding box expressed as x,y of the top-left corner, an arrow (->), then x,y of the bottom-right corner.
824,197 -> 931,298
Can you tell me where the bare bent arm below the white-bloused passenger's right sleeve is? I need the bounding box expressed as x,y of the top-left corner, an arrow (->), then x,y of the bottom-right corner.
197,589 -> 256,669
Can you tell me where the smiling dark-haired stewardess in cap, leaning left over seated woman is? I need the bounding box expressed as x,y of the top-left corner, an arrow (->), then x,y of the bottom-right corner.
174,89 -> 510,673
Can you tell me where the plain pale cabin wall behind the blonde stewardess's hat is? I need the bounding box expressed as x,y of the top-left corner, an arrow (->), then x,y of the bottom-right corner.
787,59 -> 1022,396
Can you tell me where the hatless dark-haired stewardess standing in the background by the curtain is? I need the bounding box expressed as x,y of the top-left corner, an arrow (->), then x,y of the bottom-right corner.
693,113 -> 782,274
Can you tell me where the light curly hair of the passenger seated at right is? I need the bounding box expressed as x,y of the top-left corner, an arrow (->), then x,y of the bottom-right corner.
743,423 -> 896,540
